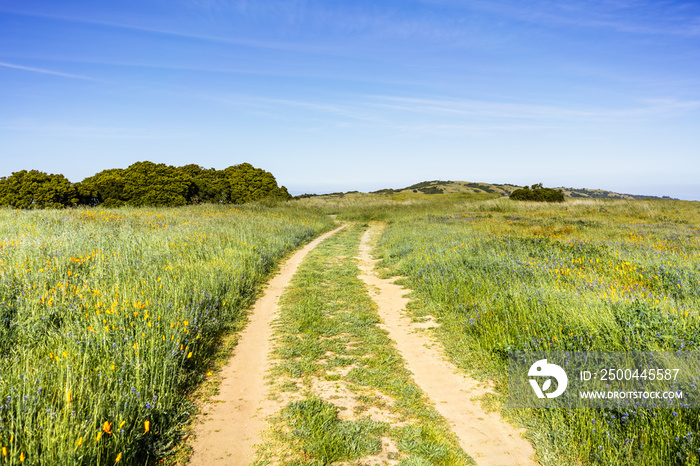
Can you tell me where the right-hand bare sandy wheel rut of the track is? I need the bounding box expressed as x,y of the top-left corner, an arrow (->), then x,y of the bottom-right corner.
358,224 -> 537,465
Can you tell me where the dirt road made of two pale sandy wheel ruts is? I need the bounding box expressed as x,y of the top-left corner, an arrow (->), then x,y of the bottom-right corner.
190,224 -> 537,466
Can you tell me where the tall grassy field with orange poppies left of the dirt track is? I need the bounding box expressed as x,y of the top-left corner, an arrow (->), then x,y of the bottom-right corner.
0,205 -> 330,465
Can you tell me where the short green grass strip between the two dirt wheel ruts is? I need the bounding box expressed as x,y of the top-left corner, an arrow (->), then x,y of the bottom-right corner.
254,225 -> 471,465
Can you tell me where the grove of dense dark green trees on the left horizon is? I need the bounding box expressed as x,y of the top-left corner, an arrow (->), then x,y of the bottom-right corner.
0,162 -> 291,209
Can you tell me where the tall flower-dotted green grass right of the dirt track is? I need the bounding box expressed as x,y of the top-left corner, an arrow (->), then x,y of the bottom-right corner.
374,199 -> 700,465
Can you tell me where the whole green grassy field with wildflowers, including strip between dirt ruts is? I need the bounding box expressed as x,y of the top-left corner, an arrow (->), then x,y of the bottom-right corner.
0,193 -> 700,465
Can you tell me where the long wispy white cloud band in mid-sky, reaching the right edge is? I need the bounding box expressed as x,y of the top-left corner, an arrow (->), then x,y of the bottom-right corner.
207,90 -> 700,135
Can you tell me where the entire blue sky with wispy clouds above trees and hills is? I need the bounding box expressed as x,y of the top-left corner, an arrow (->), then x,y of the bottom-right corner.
0,0 -> 700,200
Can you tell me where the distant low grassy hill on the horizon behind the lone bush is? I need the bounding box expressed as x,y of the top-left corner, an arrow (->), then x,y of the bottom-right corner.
374,180 -> 672,199
